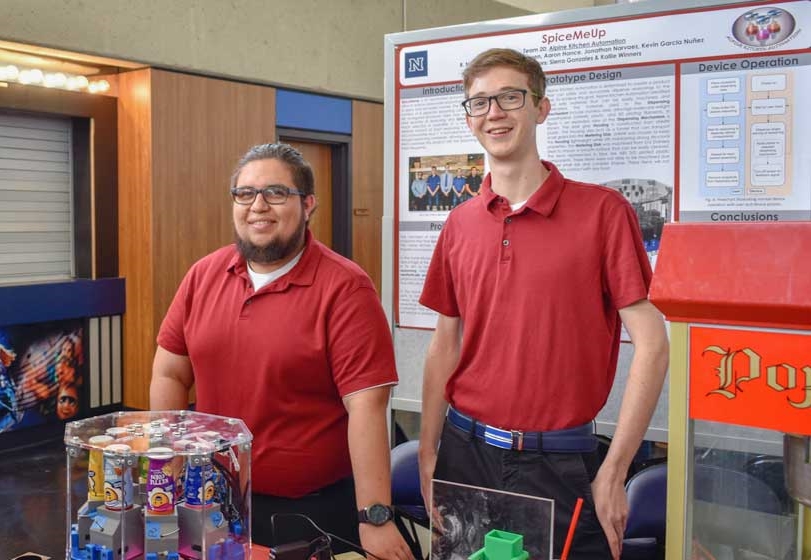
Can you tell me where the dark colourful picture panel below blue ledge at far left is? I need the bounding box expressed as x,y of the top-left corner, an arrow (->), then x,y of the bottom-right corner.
0,320 -> 86,433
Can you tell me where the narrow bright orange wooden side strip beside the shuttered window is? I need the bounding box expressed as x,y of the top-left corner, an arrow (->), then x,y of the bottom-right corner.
118,69 -> 156,408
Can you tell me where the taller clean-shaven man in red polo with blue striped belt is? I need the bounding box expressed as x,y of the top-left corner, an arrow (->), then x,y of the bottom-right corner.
420,49 -> 668,559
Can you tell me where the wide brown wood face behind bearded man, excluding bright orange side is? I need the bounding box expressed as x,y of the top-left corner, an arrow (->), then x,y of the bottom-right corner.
152,70 -> 276,328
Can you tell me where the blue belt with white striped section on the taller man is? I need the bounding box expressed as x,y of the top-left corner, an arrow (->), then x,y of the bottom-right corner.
448,406 -> 597,453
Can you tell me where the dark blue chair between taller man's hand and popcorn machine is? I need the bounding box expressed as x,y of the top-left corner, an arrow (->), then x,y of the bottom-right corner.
621,463 -> 667,560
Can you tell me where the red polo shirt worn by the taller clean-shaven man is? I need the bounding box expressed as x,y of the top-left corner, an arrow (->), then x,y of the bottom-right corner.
420,162 -> 651,430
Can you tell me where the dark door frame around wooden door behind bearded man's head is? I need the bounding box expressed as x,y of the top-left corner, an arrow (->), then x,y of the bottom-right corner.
276,127 -> 352,259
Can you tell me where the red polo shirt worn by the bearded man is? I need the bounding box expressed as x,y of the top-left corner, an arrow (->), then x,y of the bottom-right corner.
158,231 -> 397,497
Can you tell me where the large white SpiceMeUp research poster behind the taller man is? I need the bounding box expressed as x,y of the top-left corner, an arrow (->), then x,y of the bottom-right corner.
394,0 -> 811,328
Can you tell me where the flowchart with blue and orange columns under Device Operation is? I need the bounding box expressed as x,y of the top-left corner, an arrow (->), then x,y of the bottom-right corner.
699,70 -> 794,197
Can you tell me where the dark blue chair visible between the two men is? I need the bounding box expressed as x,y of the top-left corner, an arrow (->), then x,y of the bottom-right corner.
391,440 -> 430,558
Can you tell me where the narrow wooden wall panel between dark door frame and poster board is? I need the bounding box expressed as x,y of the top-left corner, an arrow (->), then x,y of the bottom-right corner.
352,101 -> 383,294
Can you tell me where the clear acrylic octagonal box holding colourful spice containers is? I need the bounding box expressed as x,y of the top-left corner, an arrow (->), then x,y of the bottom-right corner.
65,410 -> 253,560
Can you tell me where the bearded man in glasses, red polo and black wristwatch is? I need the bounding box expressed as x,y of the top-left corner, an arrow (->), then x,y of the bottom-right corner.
150,144 -> 411,560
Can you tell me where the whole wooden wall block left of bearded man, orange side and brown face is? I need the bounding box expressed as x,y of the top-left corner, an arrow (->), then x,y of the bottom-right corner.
119,70 -> 276,408
